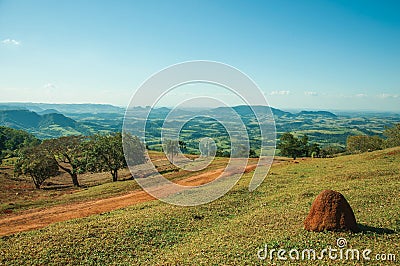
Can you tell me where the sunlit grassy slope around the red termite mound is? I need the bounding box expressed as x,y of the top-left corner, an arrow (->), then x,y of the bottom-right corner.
0,148 -> 400,265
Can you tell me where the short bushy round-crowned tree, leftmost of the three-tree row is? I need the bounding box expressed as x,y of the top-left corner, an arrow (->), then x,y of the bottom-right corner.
14,146 -> 58,189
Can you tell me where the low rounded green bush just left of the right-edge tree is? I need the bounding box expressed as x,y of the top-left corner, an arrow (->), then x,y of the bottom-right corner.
346,136 -> 383,153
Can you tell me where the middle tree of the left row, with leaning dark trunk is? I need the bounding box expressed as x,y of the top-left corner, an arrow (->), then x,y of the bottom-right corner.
41,136 -> 87,187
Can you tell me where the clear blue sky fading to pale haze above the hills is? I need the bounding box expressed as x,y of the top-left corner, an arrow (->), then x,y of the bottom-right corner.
0,0 -> 400,112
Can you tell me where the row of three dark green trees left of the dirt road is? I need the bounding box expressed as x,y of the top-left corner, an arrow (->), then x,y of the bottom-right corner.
14,132 -> 146,188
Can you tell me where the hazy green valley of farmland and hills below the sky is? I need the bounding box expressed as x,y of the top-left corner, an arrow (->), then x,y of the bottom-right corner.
0,104 -> 400,154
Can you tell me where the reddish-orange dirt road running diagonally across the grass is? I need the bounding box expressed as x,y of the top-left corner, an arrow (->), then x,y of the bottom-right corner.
0,164 -> 256,236
